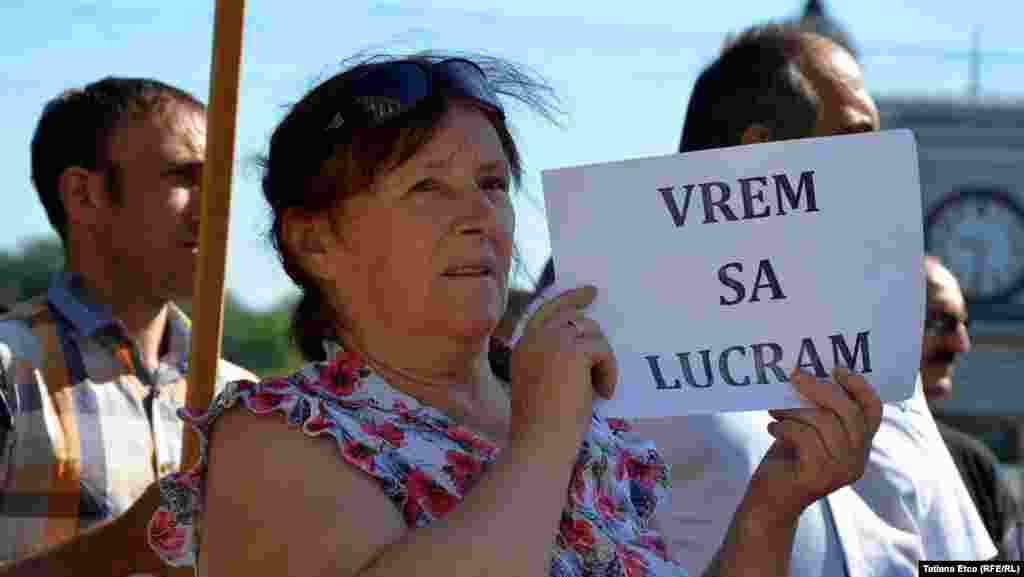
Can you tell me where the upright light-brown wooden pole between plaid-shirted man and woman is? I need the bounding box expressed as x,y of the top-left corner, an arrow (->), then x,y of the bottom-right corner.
181,0 -> 245,469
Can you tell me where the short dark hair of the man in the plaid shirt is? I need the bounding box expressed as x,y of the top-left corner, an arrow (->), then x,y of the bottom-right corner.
32,77 -> 205,244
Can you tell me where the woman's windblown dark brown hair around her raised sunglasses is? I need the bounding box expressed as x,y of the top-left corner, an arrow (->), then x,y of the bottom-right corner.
262,53 -> 557,361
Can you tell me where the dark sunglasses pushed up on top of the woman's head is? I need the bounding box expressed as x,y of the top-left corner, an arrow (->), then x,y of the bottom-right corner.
325,58 -> 502,132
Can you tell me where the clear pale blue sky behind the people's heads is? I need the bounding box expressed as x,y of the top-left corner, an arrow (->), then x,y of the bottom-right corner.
0,0 -> 1024,306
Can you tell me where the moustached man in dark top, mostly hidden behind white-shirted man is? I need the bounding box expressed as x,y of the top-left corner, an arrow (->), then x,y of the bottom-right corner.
921,256 -> 1021,555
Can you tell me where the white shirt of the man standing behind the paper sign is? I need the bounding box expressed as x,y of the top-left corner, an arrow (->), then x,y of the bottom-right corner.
634,377 -> 996,577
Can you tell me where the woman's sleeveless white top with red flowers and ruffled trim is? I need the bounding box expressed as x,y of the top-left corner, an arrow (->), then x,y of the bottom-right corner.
148,347 -> 686,577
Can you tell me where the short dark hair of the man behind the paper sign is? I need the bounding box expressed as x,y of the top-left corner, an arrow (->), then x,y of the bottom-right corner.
679,24 -> 817,153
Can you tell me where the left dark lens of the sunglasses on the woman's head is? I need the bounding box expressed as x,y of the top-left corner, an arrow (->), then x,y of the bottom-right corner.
351,63 -> 430,122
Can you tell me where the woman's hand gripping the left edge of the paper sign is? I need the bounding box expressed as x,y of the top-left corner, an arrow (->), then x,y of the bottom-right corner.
511,286 -> 618,447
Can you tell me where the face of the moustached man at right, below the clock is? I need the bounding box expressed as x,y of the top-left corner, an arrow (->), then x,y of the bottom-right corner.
921,264 -> 971,401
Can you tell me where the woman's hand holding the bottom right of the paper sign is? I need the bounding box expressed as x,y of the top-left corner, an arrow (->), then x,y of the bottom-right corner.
748,368 -> 882,522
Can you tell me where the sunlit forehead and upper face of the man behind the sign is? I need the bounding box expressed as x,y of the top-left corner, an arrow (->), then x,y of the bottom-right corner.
800,37 -> 879,136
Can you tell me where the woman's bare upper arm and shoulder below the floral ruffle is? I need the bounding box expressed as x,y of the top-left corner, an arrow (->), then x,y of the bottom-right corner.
203,406 -> 407,575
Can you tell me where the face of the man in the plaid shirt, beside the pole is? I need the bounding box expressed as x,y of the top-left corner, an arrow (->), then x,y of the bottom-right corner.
96,104 -> 206,301
